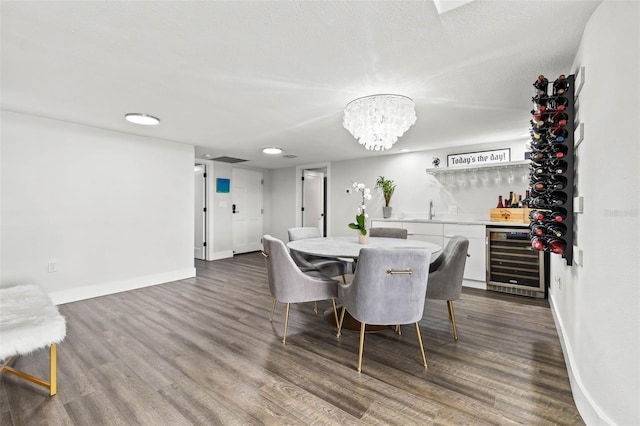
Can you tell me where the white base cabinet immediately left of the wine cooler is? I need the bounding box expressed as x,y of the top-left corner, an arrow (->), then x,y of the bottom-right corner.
443,223 -> 487,289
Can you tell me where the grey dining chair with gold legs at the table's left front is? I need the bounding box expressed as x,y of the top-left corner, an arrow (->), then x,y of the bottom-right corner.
262,235 -> 339,344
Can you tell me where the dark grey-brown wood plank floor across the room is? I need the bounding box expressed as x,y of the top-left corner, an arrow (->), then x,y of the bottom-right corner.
0,253 -> 583,425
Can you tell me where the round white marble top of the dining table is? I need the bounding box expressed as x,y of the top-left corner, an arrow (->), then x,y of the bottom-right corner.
287,237 -> 442,261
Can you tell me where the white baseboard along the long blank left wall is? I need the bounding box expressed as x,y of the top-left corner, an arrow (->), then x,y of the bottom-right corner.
49,268 -> 196,305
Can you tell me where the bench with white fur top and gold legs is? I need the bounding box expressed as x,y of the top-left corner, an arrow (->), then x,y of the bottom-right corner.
0,285 -> 67,395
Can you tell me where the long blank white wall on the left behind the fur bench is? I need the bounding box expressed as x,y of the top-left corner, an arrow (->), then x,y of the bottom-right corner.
0,111 -> 195,303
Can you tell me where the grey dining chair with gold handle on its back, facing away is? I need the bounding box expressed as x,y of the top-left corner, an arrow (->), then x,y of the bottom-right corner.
338,248 -> 431,372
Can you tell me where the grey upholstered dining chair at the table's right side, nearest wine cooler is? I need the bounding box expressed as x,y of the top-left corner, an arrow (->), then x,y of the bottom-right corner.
427,235 -> 469,340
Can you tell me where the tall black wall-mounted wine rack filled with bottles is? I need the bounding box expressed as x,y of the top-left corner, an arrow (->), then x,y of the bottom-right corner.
529,75 -> 575,265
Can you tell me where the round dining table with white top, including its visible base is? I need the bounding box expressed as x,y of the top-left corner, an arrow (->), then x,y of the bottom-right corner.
287,237 -> 442,332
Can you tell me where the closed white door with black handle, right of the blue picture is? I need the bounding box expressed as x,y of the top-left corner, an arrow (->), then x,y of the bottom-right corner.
231,167 -> 263,254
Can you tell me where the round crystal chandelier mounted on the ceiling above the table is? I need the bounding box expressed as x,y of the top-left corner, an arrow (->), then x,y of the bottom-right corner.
343,95 -> 416,151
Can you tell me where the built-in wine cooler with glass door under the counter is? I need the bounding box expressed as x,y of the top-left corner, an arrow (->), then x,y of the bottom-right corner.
487,227 -> 549,298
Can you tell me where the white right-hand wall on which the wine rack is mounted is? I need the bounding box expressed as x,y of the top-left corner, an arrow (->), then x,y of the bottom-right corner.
549,1 -> 640,425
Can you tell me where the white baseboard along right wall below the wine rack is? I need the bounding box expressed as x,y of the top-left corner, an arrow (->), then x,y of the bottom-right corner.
549,292 -> 615,425
